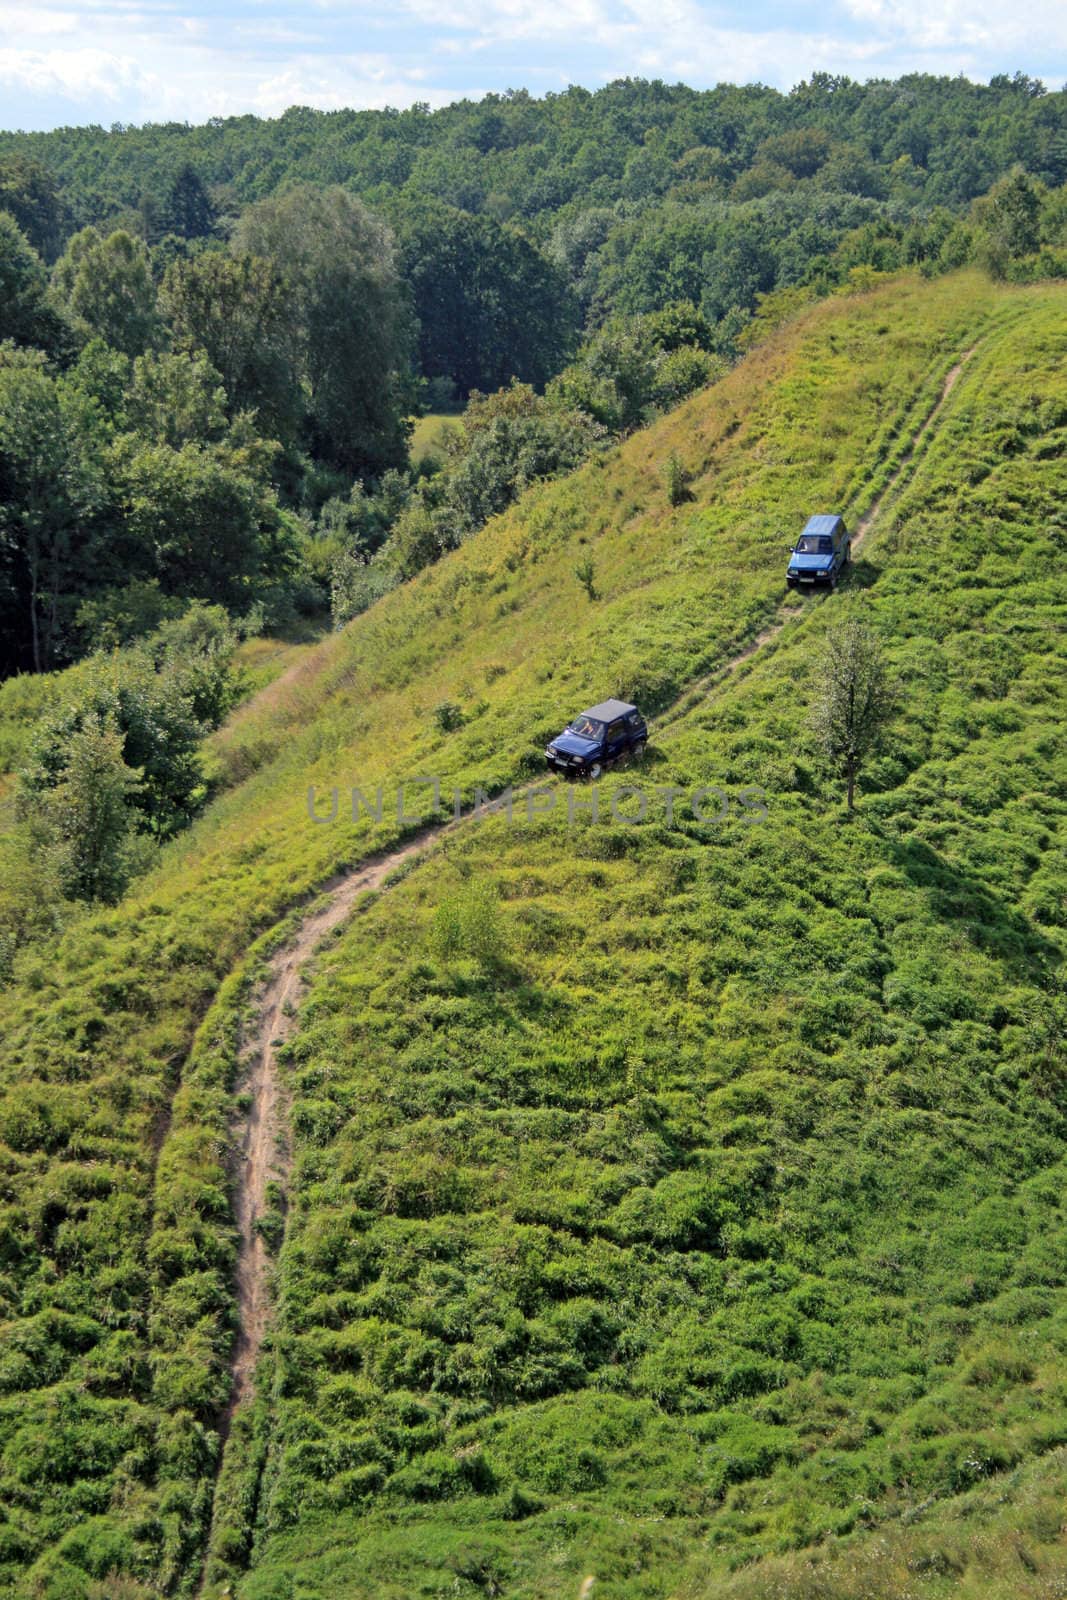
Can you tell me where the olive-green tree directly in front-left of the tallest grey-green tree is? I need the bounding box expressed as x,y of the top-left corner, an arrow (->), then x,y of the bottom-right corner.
160,251 -> 302,443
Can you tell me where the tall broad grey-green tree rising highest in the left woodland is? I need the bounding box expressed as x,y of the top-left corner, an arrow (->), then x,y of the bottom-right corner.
234,186 -> 413,477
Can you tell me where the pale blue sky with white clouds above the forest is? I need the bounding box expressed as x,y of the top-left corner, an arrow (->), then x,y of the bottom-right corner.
0,0 -> 1067,128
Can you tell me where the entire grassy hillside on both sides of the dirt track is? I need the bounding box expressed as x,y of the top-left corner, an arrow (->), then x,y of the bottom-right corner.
0,268 -> 1067,1600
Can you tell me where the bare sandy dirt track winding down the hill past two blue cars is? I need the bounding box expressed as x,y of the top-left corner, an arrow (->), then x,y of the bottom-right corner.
195,346 -> 977,1580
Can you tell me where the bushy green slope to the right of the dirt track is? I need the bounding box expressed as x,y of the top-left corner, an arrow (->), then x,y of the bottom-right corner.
219,281 -> 1067,1597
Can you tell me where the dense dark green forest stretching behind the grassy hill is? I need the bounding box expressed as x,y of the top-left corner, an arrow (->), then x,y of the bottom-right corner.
0,75 -> 1067,674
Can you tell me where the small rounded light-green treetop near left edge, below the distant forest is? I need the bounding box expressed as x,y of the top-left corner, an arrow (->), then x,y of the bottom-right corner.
53,227 -> 160,355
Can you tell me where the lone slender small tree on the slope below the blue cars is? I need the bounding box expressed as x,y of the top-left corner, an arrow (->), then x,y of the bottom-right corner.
811,618 -> 894,811
